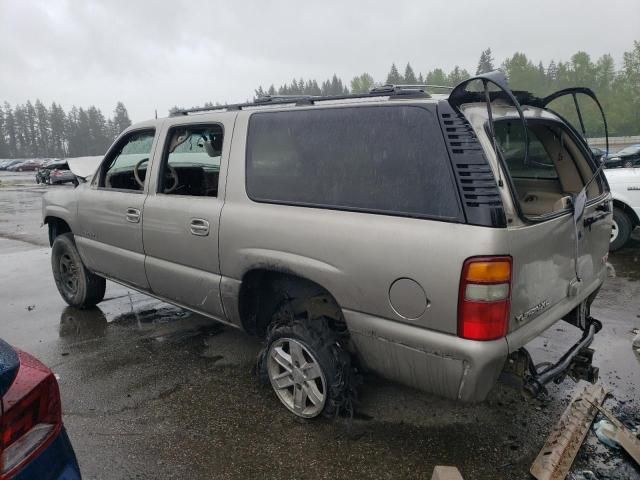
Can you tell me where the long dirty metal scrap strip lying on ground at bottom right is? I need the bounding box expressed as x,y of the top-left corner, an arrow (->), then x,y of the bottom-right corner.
529,384 -> 609,480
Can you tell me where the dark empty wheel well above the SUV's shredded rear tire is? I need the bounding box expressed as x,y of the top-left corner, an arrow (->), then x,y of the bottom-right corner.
239,269 -> 347,337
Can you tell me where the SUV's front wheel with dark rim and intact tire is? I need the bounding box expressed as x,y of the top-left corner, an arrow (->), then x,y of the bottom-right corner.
51,233 -> 106,308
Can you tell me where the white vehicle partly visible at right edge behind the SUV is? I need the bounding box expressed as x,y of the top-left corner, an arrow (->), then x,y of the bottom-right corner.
605,168 -> 640,251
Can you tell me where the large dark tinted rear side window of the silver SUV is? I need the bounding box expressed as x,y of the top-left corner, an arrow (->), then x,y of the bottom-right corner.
247,106 -> 460,219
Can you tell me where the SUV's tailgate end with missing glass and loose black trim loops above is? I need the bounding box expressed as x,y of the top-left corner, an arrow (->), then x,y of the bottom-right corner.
449,72 -> 611,394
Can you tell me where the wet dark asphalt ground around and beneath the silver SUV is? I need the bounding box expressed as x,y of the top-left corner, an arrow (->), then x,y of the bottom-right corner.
0,172 -> 640,479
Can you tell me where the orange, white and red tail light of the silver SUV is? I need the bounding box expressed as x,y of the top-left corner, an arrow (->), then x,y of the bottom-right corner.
458,256 -> 512,340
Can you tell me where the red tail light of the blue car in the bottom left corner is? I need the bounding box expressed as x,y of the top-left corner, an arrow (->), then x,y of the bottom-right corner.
0,352 -> 62,480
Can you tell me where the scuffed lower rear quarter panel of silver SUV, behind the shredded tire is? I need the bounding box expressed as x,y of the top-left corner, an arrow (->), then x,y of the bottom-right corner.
344,310 -> 509,402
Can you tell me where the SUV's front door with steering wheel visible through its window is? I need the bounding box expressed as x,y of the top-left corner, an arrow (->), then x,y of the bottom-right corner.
74,129 -> 155,290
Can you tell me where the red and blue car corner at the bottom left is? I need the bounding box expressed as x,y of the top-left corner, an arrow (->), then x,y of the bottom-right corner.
0,339 -> 80,480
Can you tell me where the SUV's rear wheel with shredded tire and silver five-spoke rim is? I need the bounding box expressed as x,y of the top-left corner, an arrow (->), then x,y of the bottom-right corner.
258,310 -> 356,418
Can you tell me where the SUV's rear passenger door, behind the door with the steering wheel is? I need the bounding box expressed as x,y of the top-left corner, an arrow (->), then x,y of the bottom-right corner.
142,121 -> 233,319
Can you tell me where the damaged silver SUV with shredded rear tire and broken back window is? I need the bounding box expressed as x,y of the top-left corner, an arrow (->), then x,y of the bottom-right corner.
43,72 -> 611,418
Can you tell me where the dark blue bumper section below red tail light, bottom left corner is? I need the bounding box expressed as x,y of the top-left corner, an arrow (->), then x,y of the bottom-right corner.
13,427 -> 81,480
